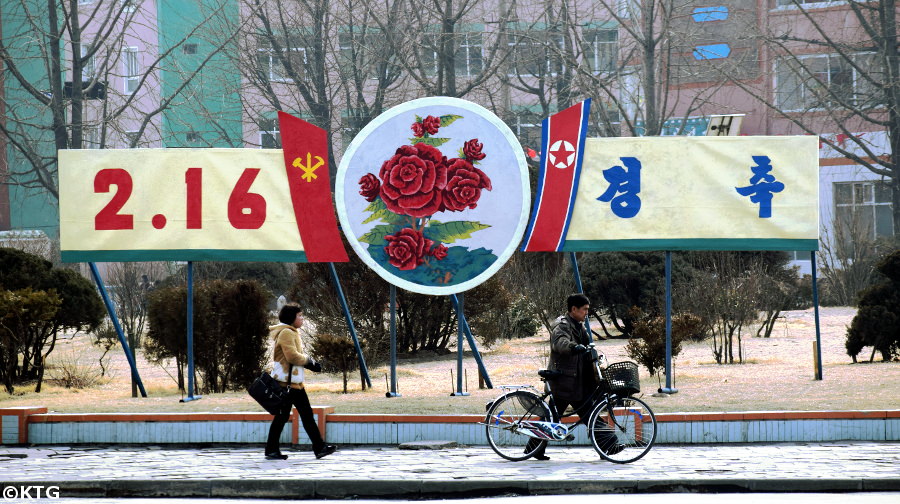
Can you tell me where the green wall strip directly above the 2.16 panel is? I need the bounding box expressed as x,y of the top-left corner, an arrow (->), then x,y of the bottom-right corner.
157,0 -> 243,147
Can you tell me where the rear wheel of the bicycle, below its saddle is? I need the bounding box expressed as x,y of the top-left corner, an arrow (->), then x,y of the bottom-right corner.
484,390 -> 552,460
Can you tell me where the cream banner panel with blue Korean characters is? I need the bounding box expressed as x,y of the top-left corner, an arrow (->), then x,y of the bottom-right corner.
563,136 -> 819,251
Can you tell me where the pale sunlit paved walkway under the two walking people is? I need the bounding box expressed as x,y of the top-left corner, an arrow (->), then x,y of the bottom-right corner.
0,442 -> 900,499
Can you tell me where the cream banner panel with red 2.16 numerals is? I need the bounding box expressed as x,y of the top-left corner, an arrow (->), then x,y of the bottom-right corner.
59,149 -> 305,261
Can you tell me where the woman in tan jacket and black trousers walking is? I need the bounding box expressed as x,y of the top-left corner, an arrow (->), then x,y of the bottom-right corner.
266,304 -> 337,460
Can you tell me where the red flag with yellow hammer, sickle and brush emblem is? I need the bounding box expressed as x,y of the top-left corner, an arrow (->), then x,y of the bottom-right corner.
278,112 -> 349,262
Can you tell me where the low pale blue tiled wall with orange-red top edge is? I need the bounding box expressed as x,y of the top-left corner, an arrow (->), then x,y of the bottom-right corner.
0,406 -> 900,445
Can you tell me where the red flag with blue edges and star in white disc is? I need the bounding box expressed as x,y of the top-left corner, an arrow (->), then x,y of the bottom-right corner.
522,98 -> 591,252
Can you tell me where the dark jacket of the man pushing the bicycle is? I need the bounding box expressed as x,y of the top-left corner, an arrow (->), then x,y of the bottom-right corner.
548,314 -> 595,405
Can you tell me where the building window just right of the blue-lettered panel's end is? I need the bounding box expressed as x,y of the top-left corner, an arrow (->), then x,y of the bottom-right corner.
834,180 -> 894,243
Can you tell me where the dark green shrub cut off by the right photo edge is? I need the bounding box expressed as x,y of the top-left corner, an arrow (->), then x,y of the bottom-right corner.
845,249 -> 900,362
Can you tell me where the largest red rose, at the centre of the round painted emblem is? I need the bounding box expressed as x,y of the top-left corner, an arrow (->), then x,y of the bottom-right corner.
378,143 -> 447,218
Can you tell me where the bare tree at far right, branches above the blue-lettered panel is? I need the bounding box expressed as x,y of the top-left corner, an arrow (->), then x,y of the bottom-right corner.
735,0 -> 900,235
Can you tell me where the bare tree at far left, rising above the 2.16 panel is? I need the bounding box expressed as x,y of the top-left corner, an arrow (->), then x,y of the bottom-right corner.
0,0 -> 244,199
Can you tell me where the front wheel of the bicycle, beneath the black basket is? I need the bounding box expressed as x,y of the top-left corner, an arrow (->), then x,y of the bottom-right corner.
588,396 -> 656,464
